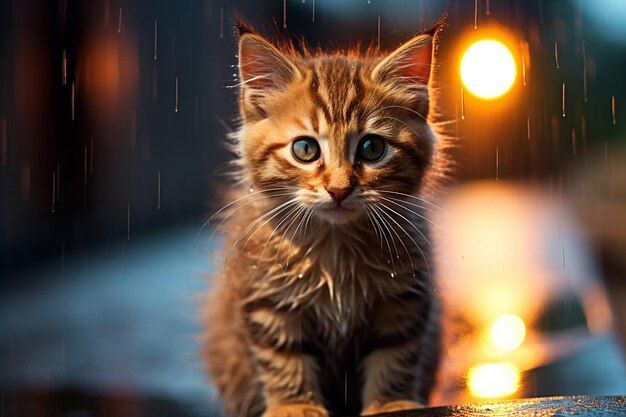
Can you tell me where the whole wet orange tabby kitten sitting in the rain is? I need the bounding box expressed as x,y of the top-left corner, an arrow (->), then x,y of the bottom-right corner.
203,24 -> 439,417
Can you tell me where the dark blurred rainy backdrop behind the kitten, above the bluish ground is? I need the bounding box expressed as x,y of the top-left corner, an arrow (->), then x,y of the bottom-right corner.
0,0 -> 626,283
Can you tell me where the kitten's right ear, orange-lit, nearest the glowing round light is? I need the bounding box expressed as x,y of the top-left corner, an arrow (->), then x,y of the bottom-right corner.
372,34 -> 433,85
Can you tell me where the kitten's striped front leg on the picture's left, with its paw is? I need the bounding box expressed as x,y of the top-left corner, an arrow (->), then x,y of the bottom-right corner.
241,303 -> 328,417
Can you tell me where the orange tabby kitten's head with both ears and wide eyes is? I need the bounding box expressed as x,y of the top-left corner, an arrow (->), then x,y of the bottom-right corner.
237,24 -> 434,224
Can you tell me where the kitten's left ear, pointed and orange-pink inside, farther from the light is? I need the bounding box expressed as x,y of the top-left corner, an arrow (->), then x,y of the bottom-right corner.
239,32 -> 299,117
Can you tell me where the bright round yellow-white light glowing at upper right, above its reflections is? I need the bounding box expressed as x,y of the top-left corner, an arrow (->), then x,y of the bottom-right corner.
461,40 -> 516,99
